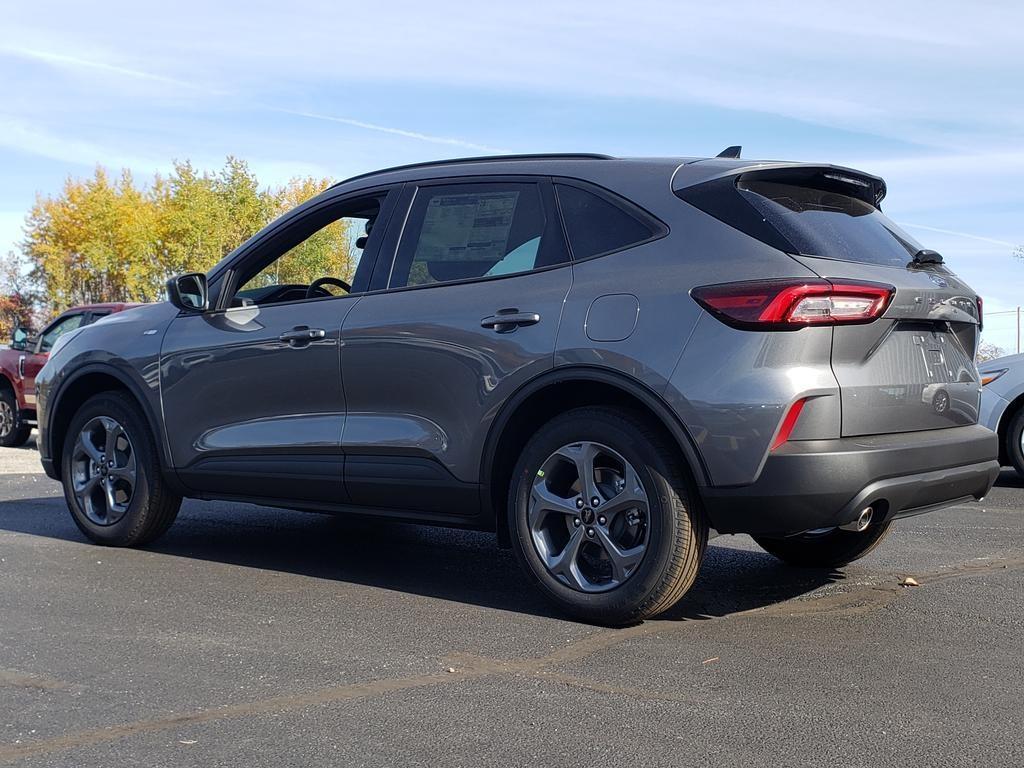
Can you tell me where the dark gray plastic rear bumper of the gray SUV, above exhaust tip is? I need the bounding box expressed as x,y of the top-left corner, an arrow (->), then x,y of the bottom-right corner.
703,425 -> 999,535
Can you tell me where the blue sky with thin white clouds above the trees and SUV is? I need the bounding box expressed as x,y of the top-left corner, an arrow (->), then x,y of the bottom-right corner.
0,0 -> 1024,351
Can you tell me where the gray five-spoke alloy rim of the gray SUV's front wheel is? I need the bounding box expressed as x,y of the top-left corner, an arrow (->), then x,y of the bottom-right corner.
72,416 -> 138,525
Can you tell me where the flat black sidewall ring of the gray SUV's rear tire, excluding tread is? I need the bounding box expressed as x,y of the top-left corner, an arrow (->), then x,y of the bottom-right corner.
509,412 -> 689,621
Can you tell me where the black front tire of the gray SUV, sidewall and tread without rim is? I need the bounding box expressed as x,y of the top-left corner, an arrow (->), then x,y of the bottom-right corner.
60,391 -> 181,547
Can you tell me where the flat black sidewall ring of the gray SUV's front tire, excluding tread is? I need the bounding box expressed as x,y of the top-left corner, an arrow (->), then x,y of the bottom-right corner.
60,393 -> 155,546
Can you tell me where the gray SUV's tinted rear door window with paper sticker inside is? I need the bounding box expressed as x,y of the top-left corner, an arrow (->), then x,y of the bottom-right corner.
389,182 -> 568,288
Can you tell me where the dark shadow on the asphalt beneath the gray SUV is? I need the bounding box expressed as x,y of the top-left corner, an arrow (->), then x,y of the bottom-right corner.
0,497 -> 843,620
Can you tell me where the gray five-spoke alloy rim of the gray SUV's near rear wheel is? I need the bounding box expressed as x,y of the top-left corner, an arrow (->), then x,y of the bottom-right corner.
527,441 -> 650,592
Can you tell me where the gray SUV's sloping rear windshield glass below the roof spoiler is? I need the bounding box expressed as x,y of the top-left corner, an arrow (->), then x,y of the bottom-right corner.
736,179 -> 921,266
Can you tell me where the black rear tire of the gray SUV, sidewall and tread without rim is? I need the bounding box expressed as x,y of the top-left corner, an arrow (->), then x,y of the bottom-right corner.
509,408 -> 708,626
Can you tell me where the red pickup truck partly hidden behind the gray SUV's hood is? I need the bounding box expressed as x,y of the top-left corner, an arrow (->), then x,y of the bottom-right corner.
0,303 -> 138,446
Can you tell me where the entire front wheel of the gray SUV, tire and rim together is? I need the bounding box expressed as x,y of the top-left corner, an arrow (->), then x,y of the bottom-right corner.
60,392 -> 181,547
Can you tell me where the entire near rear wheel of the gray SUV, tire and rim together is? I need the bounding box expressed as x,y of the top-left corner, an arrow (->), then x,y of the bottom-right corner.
509,408 -> 708,625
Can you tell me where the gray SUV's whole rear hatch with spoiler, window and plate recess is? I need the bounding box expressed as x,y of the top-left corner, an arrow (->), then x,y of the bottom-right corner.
677,166 -> 981,436
